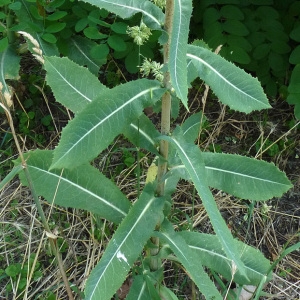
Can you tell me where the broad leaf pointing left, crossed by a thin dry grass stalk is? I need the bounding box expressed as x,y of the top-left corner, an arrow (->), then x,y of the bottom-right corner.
16,150 -> 131,223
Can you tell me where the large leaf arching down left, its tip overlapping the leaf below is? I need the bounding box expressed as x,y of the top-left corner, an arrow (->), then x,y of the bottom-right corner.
52,79 -> 165,168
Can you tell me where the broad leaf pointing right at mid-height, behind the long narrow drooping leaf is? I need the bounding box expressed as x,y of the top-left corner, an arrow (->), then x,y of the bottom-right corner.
202,152 -> 292,201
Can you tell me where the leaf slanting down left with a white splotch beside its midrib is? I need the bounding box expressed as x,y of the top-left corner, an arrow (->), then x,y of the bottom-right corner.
85,185 -> 164,300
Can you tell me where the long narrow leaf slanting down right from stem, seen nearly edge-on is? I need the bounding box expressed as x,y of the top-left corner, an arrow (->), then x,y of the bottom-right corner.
164,132 -> 245,275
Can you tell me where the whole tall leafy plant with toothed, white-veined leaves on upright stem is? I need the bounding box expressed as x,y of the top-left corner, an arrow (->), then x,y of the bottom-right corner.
0,0 -> 291,299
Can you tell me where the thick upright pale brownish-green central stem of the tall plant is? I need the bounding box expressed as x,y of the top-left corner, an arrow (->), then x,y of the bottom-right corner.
150,0 -> 174,271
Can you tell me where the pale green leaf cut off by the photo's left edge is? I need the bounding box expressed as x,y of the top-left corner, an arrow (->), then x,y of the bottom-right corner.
0,47 -> 20,94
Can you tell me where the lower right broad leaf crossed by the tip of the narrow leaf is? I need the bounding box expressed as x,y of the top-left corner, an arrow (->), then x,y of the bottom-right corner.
178,231 -> 270,285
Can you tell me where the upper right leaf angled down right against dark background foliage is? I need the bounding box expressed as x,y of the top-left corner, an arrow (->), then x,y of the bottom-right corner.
187,45 -> 271,113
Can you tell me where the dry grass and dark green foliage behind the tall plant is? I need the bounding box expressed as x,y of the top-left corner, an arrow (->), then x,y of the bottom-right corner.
0,0 -> 300,299
